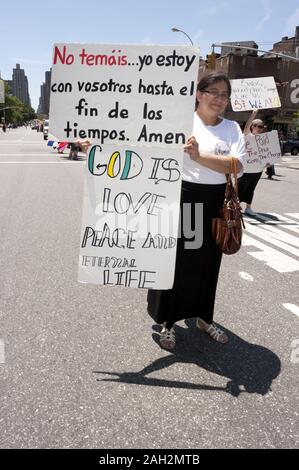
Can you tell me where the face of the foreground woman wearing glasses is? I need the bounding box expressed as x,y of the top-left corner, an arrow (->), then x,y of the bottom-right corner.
196,81 -> 229,116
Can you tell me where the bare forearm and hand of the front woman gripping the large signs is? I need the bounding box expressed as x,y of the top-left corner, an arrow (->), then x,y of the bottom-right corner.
184,136 -> 243,173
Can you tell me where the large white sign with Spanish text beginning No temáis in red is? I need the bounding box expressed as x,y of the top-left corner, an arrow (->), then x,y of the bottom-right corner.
49,44 -> 199,148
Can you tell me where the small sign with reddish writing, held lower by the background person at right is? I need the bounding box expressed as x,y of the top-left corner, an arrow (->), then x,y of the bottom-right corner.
243,131 -> 281,173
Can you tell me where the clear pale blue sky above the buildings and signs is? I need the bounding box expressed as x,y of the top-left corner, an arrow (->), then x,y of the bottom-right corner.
0,0 -> 299,109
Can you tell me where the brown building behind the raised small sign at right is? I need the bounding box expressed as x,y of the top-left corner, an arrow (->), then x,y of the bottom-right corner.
199,26 -> 299,137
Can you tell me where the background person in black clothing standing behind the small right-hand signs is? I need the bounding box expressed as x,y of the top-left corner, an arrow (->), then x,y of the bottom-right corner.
239,110 -> 265,217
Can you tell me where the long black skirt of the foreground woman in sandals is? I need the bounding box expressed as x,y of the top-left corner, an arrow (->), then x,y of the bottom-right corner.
147,181 -> 226,325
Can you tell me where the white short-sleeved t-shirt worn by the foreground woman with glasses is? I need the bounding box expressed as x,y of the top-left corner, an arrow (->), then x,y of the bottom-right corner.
182,112 -> 246,184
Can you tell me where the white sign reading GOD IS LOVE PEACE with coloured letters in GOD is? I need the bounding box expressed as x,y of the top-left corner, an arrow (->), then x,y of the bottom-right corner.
79,144 -> 183,289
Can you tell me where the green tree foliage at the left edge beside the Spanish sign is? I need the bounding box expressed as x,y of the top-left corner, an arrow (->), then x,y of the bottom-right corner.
0,83 -> 36,125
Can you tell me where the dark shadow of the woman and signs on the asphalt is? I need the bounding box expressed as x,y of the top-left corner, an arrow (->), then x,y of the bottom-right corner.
94,320 -> 281,397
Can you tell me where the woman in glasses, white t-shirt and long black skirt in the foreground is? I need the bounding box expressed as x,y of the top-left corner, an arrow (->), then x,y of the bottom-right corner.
147,72 -> 245,349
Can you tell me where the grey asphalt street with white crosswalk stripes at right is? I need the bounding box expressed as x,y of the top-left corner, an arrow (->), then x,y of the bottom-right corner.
0,127 -> 299,449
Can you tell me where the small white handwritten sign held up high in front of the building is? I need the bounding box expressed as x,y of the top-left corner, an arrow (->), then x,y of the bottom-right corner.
230,77 -> 281,111
